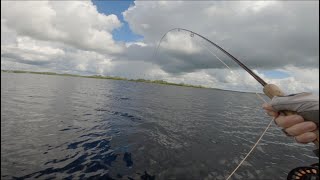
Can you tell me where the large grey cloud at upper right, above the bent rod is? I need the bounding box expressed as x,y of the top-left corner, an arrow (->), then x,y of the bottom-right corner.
124,1 -> 319,70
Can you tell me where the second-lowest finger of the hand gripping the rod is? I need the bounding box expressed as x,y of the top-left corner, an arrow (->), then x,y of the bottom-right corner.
285,121 -> 317,136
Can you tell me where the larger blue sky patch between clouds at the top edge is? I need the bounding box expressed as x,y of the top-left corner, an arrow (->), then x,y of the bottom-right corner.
92,0 -> 143,42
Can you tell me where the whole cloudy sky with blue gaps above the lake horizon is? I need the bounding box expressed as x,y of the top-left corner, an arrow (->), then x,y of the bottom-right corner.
1,1 -> 319,94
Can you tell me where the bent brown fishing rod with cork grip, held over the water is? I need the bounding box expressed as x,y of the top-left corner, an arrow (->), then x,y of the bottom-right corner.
155,28 -> 319,179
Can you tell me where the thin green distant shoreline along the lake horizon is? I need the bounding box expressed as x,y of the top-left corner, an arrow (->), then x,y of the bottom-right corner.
1,70 -> 260,94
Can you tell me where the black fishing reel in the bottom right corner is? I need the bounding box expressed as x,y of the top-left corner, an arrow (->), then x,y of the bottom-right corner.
287,163 -> 319,180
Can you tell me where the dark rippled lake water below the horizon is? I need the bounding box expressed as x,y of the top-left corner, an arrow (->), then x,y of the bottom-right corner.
1,73 -> 317,180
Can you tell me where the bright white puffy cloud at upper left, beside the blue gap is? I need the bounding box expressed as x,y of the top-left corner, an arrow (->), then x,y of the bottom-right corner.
1,1 -> 122,53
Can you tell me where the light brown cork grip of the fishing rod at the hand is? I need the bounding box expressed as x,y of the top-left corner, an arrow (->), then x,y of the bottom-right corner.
263,84 -> 319,148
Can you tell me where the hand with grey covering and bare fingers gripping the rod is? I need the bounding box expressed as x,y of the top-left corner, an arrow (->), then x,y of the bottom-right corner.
263,93 -> 319,143
